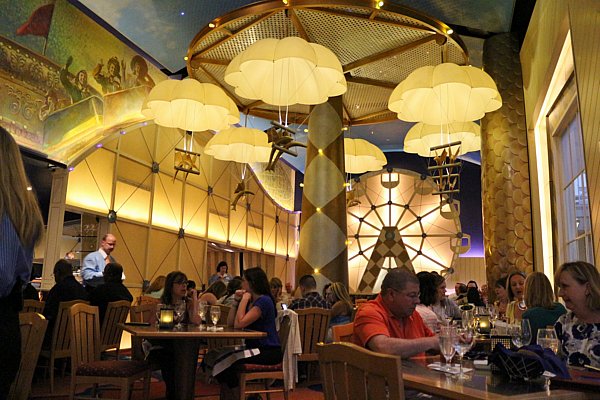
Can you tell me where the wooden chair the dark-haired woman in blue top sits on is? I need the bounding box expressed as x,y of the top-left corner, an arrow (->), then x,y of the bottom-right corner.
240,315 -> 291,400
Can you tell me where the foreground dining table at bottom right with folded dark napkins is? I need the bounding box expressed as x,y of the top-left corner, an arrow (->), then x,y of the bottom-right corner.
402,356 -> 599,400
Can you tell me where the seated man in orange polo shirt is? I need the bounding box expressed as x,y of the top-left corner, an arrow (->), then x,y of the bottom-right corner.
353,268 -> 440,358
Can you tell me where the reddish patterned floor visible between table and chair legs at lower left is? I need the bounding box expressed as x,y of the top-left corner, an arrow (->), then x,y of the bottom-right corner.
31,373 -> 324,400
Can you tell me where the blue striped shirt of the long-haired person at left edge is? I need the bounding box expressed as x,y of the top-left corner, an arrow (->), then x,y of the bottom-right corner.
0,214 -> 33,298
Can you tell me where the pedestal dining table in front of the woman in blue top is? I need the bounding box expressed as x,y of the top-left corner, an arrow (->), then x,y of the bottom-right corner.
119,323 -> 266,400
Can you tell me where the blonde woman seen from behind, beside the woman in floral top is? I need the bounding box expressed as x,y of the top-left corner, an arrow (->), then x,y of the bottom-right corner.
523,272 -> 567,344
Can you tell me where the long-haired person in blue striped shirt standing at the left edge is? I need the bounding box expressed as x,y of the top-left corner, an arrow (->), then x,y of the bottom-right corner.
0,127 -> 44,399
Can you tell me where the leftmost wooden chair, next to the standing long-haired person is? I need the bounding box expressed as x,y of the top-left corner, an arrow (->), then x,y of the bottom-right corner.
8,312 -> 48,400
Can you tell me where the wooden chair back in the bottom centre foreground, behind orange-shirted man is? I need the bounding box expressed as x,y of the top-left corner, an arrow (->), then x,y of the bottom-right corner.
317,343 -> 404,400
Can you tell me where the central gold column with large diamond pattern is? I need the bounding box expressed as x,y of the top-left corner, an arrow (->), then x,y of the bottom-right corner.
296,96 -> 348,286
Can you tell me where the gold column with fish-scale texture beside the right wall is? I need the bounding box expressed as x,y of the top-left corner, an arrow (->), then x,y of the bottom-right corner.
481,34 -> 533,287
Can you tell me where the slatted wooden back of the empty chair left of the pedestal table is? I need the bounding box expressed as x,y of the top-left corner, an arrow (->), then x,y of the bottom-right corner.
69,304 -> 100,369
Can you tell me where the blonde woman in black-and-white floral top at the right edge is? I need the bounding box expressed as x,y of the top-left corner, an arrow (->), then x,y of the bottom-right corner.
554,261 -> 600,368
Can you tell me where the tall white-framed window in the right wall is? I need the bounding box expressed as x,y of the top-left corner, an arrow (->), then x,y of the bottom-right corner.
548,79 -> 594,264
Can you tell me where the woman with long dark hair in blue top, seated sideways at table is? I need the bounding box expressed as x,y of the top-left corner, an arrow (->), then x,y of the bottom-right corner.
217,267 -> 283,400
